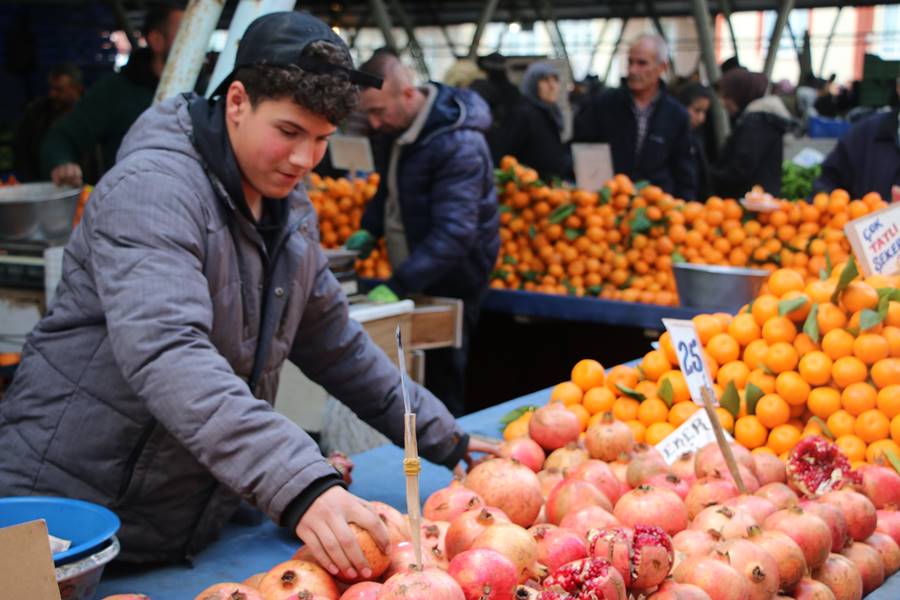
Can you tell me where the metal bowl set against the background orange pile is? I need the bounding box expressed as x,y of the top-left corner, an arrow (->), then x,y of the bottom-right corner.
672,263 -> 769,311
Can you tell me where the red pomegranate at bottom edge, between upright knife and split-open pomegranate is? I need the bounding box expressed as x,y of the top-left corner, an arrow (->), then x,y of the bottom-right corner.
447,549 -> 519,600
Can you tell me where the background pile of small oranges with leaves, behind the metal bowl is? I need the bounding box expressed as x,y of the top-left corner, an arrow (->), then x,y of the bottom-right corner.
491,156 -> 886,305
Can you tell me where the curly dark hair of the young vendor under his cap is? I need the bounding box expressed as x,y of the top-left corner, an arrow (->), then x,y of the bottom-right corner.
234,41 -> 359,125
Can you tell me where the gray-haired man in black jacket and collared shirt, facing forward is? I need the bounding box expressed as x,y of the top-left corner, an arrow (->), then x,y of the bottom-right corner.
573,34 -> 697,200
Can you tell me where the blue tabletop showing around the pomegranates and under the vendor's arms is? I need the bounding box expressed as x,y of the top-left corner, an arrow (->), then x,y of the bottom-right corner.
97,388 -> 900,600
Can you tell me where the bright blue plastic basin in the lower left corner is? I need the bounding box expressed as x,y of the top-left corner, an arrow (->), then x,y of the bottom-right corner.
0,496 -> 121,565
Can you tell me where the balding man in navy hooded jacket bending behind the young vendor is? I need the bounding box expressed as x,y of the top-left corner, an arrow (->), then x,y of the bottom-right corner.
347,58 -> 500,415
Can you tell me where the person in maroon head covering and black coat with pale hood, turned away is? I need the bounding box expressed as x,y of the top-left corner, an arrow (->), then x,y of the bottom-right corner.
710,67 -> 791,198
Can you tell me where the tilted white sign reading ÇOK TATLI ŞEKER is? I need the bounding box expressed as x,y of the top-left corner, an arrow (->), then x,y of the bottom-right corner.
844,204 -> 900,277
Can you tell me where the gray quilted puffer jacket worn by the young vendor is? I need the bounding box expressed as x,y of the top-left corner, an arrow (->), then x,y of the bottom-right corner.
0,96 -> 463,561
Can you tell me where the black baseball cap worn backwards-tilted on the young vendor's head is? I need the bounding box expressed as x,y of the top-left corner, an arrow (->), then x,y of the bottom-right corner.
212,11 -> 382,97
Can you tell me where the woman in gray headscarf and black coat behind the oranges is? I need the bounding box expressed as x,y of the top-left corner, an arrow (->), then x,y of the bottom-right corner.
497,61 -> 572,182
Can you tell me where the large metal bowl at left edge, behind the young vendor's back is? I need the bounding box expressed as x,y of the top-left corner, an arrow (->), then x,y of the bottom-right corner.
0,183 -> 81,244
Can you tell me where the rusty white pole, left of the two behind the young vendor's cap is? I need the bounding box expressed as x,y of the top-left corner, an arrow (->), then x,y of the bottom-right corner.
153,0 -> 225,103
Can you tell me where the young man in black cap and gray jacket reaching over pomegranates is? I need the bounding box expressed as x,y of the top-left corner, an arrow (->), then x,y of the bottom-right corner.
0,12 -> 486,577
